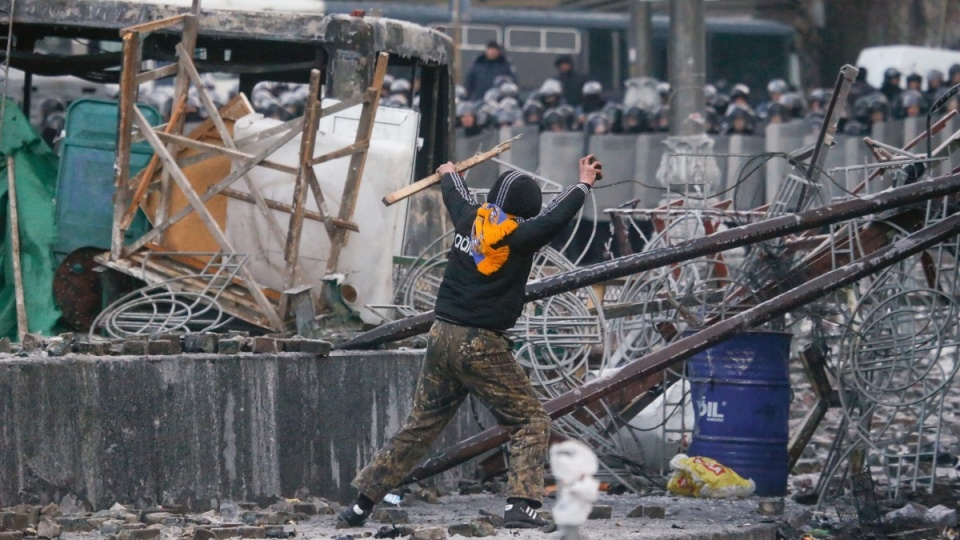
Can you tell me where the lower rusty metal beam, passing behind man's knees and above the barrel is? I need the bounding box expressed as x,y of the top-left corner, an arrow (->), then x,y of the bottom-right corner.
401,209 -> 960,484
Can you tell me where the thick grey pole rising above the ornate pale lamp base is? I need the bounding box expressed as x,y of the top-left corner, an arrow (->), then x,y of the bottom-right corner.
667,0 -> 707,136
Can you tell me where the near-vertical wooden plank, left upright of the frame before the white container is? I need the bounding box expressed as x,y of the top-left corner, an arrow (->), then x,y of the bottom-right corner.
283,69 -> 326,288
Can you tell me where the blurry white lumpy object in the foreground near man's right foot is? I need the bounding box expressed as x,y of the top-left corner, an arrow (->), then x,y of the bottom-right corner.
550,440 -> 600,540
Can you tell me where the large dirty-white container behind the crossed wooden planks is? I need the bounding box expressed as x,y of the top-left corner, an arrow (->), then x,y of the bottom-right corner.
226,99 -> 419,323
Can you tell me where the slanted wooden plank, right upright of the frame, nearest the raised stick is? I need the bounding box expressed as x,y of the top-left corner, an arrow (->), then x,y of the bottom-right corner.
327,52 -> 390,274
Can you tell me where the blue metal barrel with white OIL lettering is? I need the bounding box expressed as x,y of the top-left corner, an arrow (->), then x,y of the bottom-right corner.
687,332 -> 791,496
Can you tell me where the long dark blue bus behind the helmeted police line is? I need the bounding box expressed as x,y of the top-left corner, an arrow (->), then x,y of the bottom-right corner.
324,0 -> 800,97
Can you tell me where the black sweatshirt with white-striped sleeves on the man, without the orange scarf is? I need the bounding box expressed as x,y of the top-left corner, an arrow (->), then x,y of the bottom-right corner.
434,174 -> 590,332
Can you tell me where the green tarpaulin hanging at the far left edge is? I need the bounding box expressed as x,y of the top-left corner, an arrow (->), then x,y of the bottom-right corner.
0,99 -> 60,339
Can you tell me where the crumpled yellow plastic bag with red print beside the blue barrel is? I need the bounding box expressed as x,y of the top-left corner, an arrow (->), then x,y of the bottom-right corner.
667,454 -> 757,499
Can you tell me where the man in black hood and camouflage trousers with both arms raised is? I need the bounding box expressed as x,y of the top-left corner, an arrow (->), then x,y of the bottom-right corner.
338,155 -> 601,528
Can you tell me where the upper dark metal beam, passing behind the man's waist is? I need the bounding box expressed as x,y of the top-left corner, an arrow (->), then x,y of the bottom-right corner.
339,175 -> 960,350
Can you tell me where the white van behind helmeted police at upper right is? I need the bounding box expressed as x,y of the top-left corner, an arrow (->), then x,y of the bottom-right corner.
857,45 -> 960,89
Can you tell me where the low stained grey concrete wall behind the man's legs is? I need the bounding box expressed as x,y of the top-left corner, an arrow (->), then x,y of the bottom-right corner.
0,351 -> 477,510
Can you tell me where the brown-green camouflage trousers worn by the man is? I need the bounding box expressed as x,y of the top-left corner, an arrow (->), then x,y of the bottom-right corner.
353,321 -> 550,503
